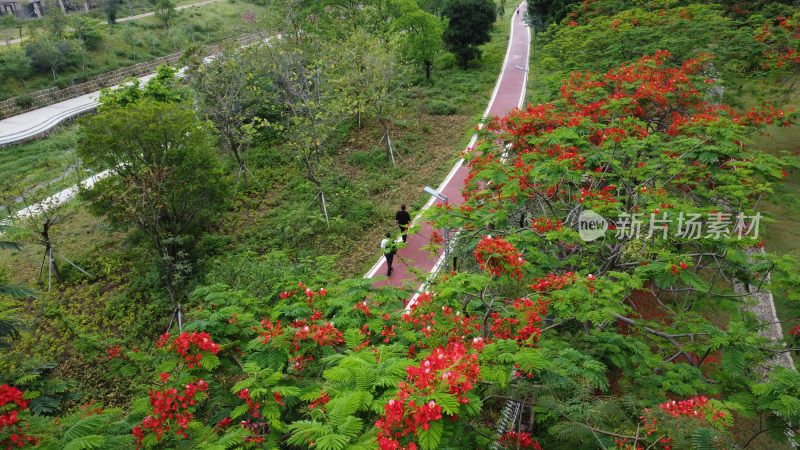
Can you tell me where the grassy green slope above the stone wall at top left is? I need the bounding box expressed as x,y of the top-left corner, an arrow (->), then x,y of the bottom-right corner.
0,0 -> 265,99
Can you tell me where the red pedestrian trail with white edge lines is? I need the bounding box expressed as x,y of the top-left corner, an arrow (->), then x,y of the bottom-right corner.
364,3 -> 531,301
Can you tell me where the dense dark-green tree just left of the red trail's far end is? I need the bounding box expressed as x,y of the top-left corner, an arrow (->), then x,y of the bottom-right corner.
442,0 -> 497,68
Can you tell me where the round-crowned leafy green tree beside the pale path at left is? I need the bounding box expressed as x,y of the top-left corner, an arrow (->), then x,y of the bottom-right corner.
77,100 -> 227,306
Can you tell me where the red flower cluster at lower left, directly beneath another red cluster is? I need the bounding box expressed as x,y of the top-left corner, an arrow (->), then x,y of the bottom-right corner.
131,379 -> 208,449
